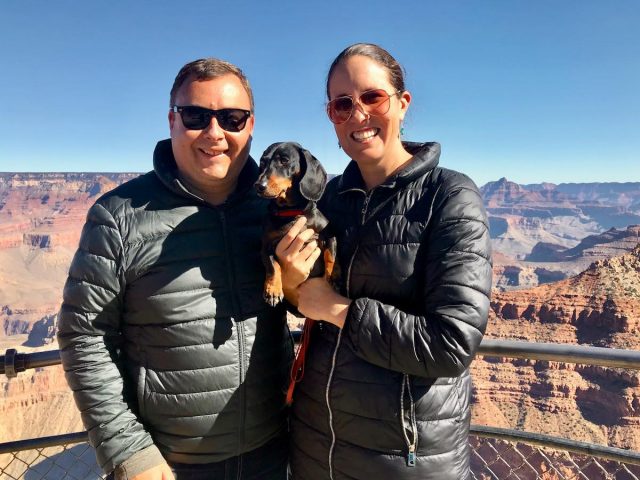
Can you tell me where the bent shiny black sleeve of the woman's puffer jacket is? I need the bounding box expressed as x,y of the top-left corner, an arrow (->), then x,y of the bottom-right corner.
345,177 -> 492,378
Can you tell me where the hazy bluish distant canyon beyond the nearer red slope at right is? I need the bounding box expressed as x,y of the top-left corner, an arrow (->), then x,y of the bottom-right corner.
480,178 -> 640,290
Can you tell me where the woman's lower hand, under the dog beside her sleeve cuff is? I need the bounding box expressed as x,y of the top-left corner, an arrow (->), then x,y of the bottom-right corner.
298,277 -> 351,328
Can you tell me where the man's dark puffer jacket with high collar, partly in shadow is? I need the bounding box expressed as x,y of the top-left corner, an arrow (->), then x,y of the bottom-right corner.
58,141 -> 292,472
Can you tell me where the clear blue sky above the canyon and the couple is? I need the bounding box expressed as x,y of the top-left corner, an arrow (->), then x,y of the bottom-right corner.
0,0 -> 640,185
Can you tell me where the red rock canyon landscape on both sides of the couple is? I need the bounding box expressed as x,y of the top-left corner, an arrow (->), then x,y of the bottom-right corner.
0,173 -> 640,468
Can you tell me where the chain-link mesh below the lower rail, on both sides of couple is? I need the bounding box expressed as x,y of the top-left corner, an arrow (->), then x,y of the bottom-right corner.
0,431 -> 640,480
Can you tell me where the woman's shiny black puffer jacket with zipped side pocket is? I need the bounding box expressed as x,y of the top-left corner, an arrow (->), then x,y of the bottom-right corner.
291,143 -> 491,480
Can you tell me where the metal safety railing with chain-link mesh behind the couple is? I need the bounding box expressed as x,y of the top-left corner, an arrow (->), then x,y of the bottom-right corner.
0,340 -> 640,480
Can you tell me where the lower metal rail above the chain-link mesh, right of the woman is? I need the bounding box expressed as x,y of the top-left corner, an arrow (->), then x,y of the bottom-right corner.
471,425 -> 640,465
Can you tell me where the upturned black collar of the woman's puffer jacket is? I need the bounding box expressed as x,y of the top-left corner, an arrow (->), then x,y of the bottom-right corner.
338,142 -> 440,193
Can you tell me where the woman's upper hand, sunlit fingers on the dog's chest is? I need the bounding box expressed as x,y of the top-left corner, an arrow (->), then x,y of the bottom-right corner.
276,217 -> 320,306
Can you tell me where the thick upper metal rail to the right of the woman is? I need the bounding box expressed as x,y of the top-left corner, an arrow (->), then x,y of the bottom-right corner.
478,339 -> 640,370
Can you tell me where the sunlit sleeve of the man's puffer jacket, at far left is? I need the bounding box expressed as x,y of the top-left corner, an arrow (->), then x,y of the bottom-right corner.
58,204 -> 158,472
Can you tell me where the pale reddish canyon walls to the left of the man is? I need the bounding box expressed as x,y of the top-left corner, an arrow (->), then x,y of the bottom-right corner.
0,173 -> 137,442
